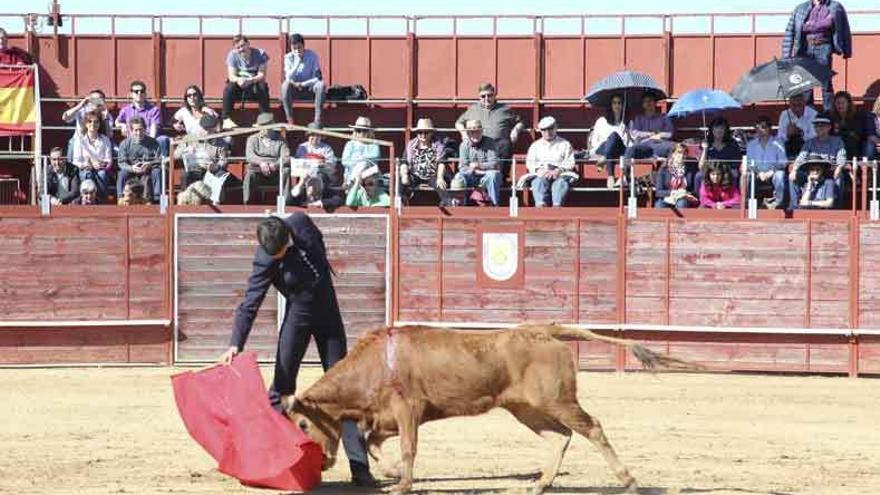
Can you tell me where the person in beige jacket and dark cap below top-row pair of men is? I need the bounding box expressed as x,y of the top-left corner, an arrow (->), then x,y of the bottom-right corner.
244,113 -> 290,204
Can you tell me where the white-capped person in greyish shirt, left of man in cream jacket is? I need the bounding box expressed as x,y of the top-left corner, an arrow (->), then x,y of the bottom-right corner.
452,119 -> 504,206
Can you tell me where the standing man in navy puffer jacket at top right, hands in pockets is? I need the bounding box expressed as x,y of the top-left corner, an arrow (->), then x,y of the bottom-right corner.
782,0 -> 852,111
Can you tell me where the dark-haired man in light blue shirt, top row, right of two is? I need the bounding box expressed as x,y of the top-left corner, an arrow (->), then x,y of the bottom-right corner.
281,33 -> 326,124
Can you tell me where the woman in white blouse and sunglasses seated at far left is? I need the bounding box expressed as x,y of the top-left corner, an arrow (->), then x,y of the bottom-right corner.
73,111 -> 113,198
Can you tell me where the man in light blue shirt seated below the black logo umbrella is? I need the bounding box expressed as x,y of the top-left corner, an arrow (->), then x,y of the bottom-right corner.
746,115 -> 788,210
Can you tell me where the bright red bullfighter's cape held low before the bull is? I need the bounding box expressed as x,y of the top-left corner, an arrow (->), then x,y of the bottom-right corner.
171,352 -> 322,491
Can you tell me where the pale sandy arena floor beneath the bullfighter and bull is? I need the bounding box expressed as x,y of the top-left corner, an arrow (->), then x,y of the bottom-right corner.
0,368 -> 880,495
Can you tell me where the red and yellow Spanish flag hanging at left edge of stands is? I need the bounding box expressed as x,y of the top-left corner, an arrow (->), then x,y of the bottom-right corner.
0,66 -> 37,136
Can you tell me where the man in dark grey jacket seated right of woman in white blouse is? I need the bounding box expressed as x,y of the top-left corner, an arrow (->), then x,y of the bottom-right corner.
116,116 -> 162,203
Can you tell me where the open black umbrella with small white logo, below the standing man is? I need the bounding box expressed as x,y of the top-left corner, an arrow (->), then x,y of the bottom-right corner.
730,57 -> 834,105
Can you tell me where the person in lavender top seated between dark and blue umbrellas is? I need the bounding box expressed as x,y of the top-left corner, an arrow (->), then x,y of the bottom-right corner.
617,93 -> 675,185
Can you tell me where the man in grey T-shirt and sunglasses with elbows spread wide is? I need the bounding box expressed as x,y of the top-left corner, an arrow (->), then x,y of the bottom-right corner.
455,83 -> 525,160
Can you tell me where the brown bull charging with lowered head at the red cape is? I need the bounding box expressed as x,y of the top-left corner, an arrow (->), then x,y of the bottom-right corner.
284,324 -> 696,494
